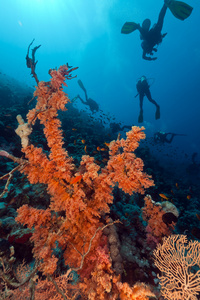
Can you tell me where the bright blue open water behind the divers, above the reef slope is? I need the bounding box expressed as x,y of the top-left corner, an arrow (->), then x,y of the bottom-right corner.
0,0 -> 200,157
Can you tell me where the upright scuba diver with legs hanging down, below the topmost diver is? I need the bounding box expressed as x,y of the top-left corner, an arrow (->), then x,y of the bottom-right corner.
135,76 -> 160,123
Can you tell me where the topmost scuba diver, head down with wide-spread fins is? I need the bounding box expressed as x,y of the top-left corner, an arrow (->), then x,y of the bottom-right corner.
121,0 -> 193,60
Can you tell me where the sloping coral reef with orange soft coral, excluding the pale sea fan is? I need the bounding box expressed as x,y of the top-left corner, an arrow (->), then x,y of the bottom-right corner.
0,65 -> 200,300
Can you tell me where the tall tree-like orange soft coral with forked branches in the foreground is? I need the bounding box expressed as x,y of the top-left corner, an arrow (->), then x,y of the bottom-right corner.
16,65 -> 153,299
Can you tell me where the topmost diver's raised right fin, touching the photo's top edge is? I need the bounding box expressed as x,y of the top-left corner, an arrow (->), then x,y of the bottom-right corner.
165,0 -> 193,21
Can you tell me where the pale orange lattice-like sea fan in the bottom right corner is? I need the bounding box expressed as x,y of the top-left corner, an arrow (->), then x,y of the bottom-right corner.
154,235 -> 200,300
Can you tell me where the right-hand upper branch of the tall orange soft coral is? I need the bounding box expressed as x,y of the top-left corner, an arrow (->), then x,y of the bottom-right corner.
107,126 -> 153,195
